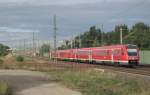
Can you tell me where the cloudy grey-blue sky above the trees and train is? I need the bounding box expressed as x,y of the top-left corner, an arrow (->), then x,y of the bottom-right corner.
0,0 -> 150,45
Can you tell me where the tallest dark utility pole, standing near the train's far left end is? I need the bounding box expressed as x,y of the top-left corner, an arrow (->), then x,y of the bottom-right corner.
53,15 -> 57,61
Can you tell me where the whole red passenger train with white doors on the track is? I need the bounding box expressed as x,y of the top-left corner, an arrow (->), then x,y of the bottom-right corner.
54,44 -> 139,65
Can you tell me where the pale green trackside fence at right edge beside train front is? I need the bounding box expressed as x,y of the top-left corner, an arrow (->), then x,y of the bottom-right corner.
140,51 -> 150,64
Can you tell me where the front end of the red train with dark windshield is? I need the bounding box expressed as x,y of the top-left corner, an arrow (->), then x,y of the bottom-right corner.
127,45 -> 139,65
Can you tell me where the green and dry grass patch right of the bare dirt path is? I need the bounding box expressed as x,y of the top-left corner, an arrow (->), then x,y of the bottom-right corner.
49,70 -> 150,95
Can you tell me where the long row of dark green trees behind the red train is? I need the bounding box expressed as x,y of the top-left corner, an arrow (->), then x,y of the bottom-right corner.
58,22 -> 150,49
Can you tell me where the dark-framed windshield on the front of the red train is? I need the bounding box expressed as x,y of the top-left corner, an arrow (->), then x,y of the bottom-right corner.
127,45 -> 138,56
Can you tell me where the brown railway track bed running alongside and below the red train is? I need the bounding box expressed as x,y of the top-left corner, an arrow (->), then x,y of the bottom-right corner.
25,58 -> 150,76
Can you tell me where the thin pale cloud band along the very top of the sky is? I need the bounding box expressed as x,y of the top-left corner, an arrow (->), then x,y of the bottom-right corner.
0,0 -> 143,5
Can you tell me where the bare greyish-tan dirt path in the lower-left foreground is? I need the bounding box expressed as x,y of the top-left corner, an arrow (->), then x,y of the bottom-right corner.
0,70 -> 81,95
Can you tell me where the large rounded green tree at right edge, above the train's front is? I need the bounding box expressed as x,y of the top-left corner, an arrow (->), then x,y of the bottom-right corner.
126,22 -> 150,48
